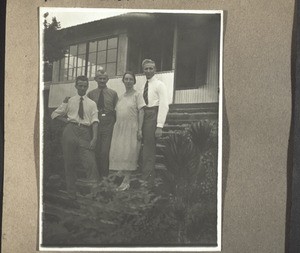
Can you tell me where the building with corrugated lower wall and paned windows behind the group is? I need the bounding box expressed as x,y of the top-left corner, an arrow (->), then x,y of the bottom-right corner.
48,13 -> 221,112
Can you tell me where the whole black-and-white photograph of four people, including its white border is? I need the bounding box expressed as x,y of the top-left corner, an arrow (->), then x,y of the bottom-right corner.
39,8 -> 223,251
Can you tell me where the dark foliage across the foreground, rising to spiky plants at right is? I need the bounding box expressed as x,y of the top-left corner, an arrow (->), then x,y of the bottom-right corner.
44,121 -> 217,246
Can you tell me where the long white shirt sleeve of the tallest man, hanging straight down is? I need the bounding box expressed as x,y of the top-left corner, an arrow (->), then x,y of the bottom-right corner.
156,82 -> 169,128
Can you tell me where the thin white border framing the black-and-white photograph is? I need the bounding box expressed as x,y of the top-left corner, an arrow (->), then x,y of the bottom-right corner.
38,7 -> 224,252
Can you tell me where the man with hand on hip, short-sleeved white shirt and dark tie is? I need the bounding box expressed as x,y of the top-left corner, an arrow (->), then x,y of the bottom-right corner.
51,76 -> 99,199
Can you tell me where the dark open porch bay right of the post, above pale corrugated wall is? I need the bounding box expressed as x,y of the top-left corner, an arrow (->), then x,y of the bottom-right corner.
175,15 -> 220,90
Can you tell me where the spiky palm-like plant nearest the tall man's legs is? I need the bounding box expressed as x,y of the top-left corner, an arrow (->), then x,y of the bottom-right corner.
164,132 -> 198,243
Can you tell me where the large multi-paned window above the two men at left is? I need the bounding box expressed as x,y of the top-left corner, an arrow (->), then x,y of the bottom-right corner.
59,37 -> 118,81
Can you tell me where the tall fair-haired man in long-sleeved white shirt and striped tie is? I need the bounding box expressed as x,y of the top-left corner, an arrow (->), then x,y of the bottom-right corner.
142,59 -> 169,181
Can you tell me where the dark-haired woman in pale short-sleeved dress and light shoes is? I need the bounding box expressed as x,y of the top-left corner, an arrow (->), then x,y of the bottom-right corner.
109,71 -> 146,190
